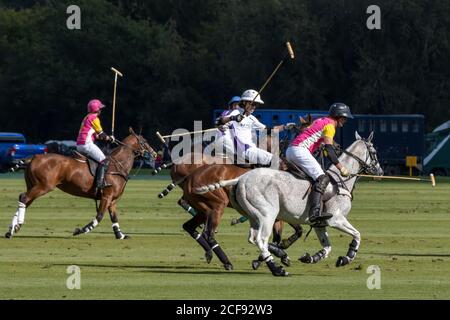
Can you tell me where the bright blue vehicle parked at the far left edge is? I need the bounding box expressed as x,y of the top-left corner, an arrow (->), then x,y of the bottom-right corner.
0,132 -> 48,171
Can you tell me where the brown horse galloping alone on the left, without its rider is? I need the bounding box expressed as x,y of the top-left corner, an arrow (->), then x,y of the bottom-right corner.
5,128 -> 156,239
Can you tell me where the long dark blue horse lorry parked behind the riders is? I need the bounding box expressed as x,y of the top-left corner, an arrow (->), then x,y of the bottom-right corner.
213,109 -> 425,175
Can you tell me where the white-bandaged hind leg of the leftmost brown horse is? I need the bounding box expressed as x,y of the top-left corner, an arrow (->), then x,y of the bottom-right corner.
5,185 -> 52,238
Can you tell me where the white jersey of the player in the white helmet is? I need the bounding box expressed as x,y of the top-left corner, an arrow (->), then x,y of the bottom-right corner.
229,110 -> 266,149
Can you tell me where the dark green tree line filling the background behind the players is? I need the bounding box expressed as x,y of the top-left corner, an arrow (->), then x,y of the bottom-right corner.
0,0 -> 450,142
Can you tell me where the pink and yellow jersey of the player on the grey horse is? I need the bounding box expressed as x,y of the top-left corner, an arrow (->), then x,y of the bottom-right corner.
291,117 -> 336,153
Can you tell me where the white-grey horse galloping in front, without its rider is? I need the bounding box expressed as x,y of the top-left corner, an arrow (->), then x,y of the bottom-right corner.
197,132 -> 383,276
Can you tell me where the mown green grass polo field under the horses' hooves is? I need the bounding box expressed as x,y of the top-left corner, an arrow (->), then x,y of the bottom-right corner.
0,175 -> 450,299
